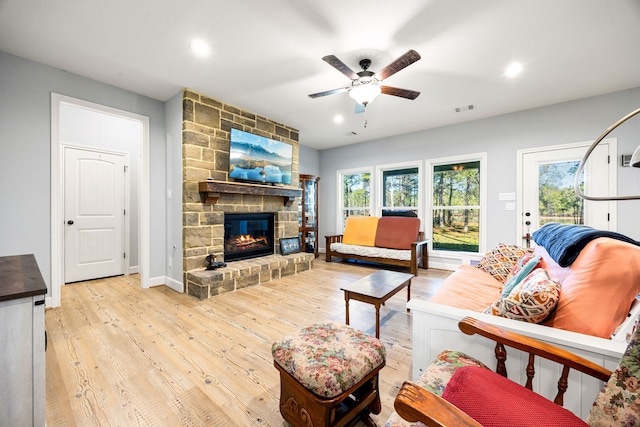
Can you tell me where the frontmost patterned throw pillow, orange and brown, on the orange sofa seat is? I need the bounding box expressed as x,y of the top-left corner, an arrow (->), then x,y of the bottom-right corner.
484,268 -> 560,323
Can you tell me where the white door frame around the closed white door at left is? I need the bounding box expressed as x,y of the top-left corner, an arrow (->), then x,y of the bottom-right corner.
60,144 -> 131,285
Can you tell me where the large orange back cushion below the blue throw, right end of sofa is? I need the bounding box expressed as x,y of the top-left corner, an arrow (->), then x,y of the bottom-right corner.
546,237 -> 640,338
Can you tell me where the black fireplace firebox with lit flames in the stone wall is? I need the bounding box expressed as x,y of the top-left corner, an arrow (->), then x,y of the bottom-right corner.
224,213 -> 274,261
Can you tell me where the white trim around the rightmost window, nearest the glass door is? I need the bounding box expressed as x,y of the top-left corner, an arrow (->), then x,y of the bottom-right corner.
424,152 -> 488,256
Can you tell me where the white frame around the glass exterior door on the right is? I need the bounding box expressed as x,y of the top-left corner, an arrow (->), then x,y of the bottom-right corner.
515,138 -> 618,242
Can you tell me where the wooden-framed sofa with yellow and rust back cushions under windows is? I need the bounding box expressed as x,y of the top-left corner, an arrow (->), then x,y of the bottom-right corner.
325,216 -> 429,276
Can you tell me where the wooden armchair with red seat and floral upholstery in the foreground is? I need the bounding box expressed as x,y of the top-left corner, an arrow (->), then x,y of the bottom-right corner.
385,318 -> 640,427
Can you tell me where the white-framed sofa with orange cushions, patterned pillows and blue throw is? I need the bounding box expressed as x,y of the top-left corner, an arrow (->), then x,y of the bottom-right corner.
407,225 -> 640,419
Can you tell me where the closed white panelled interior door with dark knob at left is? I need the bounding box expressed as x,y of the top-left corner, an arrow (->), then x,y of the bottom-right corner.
64,147 -> 125,283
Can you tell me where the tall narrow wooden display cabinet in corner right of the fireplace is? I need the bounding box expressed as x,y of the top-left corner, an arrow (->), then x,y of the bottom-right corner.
298,175 -> 320,258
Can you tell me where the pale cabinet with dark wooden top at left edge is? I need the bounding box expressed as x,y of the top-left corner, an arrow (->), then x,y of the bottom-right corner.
0,255 -> 47,427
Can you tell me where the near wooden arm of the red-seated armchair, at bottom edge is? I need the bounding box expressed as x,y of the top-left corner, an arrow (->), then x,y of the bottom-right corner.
393,381 -> 480,427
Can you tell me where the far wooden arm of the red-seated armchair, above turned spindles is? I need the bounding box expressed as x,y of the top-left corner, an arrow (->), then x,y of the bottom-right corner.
458,317 -> 611,381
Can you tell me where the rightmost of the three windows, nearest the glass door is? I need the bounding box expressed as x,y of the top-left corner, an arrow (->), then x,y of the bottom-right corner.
431,155 -> 486,252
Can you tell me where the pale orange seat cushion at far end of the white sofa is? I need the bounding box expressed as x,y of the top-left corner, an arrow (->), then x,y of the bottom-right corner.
429,265 -> 502,313
